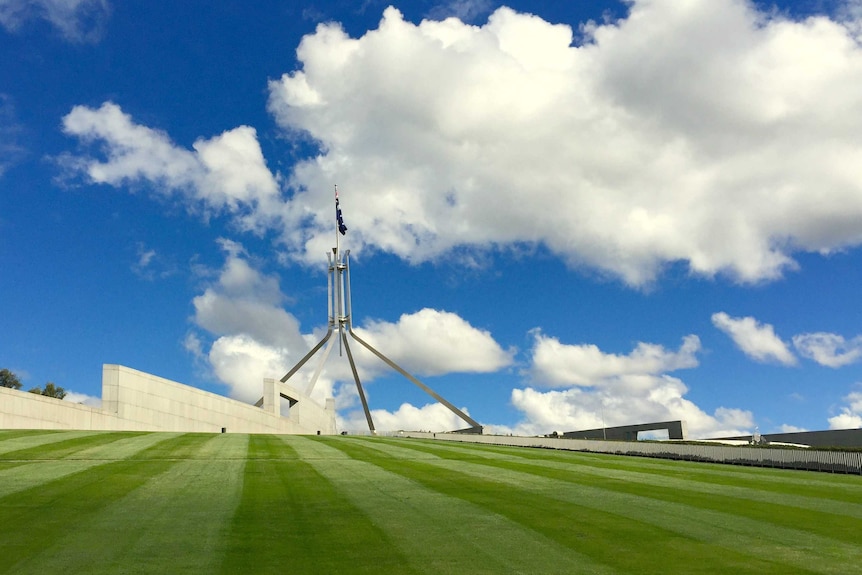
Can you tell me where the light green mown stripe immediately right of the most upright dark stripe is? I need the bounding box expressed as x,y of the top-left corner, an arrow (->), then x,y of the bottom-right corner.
304,437 -> 615,574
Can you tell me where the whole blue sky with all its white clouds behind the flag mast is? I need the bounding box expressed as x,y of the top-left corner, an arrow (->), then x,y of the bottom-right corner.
0,0 -> 862,437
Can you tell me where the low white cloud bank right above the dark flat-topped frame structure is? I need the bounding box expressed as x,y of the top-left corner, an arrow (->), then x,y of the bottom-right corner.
506,332 -> 753,437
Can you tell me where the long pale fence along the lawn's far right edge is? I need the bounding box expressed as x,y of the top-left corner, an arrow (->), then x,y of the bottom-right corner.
402,431 -> 862,475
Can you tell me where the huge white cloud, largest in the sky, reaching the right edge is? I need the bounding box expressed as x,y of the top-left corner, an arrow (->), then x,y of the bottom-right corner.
269,0 -> 862,284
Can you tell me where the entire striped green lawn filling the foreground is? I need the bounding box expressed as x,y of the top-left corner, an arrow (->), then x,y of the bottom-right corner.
0,431 -> 862,575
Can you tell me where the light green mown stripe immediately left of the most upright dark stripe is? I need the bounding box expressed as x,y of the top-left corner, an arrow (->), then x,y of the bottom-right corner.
7,434 -> 248,575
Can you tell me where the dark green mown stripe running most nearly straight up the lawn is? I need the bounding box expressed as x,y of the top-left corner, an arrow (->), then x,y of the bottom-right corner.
215,435 -> 414,575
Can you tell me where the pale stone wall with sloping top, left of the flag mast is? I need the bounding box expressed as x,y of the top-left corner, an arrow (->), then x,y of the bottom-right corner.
0,365 -> 336,435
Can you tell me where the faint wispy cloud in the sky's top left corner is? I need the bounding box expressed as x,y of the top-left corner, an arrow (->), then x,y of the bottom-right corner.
0,0 -> 111,42
